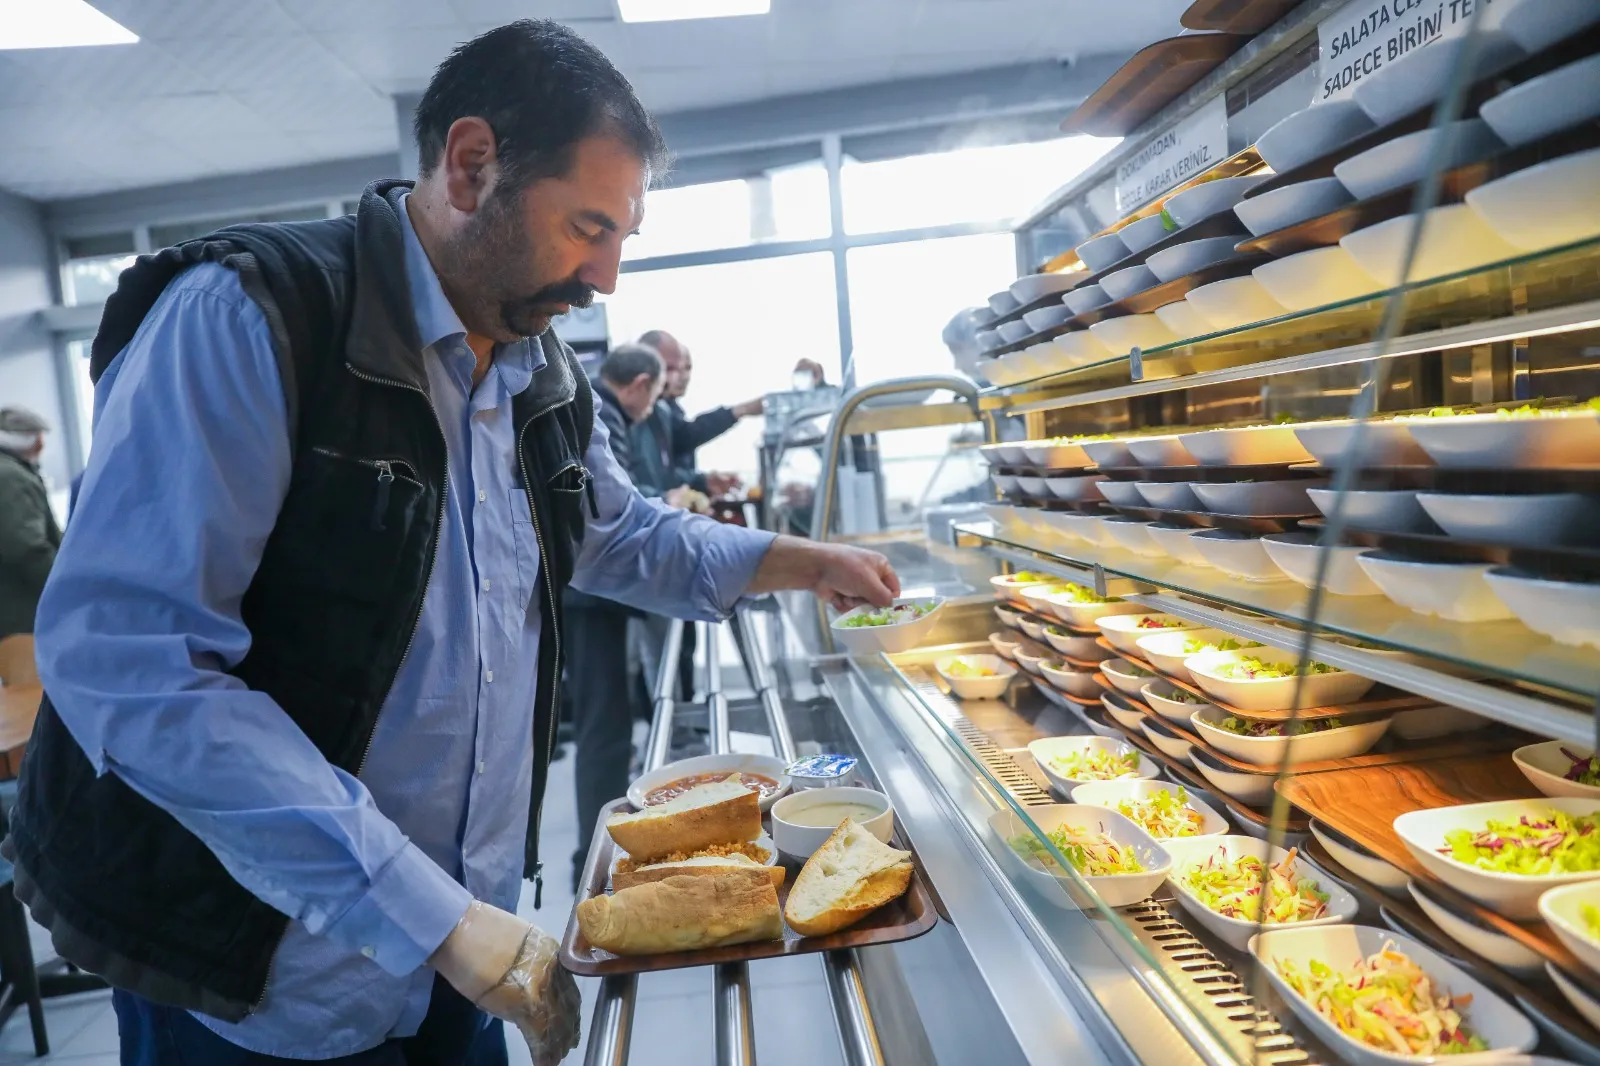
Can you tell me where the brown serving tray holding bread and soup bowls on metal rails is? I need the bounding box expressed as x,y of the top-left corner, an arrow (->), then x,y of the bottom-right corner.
562,799 -> 939,976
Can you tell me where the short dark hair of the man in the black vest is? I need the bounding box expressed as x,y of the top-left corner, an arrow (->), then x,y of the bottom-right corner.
411,19 -> 667,189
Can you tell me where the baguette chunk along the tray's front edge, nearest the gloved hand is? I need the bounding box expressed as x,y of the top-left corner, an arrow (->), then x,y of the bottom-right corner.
578,868 -> 784,956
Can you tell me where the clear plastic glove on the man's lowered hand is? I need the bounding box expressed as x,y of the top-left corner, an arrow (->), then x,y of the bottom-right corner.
429,900 -> 582,1066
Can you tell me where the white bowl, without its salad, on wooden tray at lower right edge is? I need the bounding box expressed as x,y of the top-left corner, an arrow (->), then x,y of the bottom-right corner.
1394,799 -> 1600,922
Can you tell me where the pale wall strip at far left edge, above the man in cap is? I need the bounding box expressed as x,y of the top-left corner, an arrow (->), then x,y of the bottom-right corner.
0,192 -> 70,488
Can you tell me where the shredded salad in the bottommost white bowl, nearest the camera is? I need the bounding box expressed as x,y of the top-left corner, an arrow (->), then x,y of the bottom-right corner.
1272,941 -> 1490,1056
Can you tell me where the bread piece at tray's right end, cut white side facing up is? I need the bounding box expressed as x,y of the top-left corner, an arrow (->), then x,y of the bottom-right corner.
784,818 -> 912,936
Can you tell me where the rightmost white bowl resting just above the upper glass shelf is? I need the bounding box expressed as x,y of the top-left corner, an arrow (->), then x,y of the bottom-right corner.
1467,149 -> 1600,251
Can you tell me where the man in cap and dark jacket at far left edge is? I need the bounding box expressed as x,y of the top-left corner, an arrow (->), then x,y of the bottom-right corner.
0,407 -> 61,646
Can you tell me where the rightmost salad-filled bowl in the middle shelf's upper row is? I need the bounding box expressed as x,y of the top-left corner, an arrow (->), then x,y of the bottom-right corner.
1411,408 -> 1600,469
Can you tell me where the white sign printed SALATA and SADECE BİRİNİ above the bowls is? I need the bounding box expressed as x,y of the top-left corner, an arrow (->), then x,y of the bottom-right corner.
1312,0 -> 1504,104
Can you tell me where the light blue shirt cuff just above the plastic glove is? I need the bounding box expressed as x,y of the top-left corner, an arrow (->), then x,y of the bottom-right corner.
312,842 -> 472,976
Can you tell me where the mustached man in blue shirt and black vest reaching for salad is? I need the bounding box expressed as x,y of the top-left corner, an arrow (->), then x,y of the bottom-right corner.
5,21 -> 898,1066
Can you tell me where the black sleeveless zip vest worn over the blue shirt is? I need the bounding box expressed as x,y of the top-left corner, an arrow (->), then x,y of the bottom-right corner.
5,181 -> 594,1020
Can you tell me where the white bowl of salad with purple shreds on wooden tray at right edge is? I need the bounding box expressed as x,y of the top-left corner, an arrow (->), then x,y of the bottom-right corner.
1394,799 -> 1600,922
